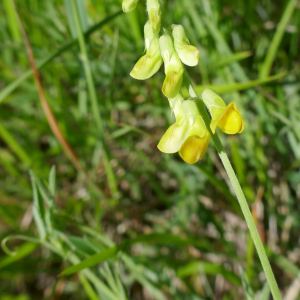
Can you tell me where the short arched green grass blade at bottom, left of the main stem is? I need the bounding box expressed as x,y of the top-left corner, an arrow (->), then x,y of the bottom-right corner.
176,261 -> 241,286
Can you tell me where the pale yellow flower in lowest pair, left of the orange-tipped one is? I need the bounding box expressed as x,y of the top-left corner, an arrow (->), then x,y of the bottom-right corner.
157,95 -> 188,153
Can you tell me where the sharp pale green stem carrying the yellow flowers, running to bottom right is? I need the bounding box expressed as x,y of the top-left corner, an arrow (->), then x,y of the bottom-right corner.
183,70 -> 282,300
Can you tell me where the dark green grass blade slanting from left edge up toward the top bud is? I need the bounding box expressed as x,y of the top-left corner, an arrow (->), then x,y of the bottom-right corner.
0,10 -> 122,104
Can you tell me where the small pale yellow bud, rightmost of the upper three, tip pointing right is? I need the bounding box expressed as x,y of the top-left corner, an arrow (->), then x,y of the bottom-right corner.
172,25 -> 200,67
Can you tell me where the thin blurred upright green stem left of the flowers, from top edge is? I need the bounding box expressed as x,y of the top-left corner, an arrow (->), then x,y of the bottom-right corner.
72,0 -> 118,197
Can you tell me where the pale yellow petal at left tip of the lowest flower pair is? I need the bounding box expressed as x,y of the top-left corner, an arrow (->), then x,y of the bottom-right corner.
157,121 -> 188,153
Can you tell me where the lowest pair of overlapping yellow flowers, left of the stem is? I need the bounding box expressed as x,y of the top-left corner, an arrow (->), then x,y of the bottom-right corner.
157,95 -> 210,164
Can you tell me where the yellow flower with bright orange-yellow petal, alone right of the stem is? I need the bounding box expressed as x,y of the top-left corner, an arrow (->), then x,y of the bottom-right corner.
202,89 -> 244,134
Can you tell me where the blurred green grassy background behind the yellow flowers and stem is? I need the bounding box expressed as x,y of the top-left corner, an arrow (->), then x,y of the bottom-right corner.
0,0 -> 300,300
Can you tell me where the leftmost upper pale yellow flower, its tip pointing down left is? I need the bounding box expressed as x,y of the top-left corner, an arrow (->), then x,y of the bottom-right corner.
130,21 -> 163,80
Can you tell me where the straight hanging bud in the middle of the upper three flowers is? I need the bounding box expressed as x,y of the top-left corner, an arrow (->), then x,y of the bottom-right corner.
159,34 -> 183,98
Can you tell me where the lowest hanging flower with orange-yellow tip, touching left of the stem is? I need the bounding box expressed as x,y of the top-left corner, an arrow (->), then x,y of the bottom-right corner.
179,100 -> 210,164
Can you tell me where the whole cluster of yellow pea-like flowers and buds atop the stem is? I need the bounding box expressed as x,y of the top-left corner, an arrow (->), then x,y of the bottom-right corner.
123,0 -> 244,164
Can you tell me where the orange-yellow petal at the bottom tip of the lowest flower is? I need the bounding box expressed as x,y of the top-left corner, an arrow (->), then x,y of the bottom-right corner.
179,134 -> 210,164
